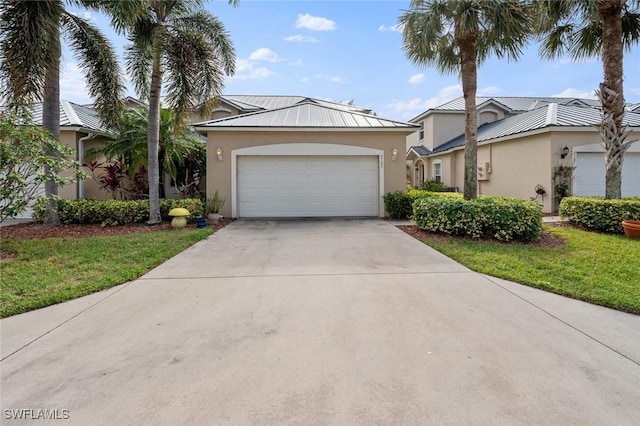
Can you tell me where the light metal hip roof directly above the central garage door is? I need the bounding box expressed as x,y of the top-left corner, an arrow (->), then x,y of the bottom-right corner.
195,101 -> 418,130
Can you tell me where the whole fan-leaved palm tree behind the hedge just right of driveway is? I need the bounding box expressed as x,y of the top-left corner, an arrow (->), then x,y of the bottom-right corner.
398,0 -> 531,200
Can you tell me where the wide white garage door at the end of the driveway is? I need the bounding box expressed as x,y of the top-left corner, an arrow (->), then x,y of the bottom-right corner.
238,156 -> 379,217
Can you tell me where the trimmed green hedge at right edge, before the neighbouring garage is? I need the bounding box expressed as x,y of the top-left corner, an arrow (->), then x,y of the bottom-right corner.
558,197 -> 640,234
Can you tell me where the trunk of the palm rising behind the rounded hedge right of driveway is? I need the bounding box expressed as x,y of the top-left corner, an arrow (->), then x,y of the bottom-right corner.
456,33 -> 478,200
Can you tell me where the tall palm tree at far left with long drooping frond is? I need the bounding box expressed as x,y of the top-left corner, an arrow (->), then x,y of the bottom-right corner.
0,0 -> 124,225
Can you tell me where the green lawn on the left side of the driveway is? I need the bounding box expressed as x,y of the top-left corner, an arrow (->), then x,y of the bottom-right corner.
0,228 -> 211,318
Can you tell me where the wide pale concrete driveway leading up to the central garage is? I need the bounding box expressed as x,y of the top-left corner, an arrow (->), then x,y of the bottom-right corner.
0,220 -> 640,425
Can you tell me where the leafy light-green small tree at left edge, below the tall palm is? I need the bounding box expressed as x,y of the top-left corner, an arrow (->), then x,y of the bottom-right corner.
0,114 -> 83,222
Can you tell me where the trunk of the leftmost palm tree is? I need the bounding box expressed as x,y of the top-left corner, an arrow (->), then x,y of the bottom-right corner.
42,32 -> 61,226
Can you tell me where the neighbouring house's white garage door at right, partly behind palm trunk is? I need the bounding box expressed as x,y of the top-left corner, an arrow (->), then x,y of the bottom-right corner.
573,151 -> 640,197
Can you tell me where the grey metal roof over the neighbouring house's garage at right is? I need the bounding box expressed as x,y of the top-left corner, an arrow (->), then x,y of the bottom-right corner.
432,103 -> 640,153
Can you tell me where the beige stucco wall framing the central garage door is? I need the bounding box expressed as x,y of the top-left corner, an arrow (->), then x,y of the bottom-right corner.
207,130 -> 406,217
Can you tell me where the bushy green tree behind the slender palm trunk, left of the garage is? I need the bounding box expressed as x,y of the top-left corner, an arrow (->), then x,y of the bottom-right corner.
86,108 -> 207,200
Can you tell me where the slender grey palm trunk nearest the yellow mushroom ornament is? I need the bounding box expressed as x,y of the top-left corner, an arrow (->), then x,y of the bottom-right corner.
147,43 -> 162,225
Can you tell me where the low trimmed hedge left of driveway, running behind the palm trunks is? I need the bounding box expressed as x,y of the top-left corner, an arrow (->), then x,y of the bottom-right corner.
33,198 -> 204,226
